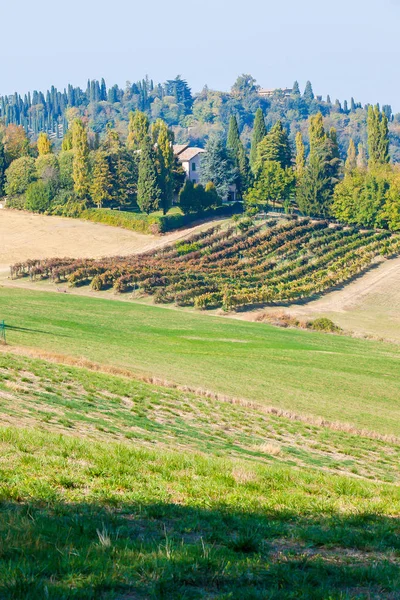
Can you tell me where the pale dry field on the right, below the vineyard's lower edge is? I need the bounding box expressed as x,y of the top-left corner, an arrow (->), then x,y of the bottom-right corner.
242,258 -> 400,342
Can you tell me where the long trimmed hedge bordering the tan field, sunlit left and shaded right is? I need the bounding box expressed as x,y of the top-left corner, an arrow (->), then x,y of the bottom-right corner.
80,202 -> 243,233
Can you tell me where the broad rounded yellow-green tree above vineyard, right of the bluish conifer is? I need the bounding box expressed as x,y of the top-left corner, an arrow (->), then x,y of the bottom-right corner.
245,160 -> 294,206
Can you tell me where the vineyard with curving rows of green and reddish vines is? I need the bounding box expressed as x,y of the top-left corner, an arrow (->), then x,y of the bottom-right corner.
11,219 -> 400,310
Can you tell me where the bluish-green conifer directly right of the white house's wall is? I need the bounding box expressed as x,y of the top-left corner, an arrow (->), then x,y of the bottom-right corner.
201,135 -> 237,200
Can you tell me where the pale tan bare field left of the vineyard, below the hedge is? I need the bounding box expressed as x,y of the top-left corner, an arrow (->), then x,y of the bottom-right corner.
0,209 -> 222,272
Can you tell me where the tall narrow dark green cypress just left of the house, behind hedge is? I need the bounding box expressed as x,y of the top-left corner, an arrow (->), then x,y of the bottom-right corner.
137,135 -> 161,214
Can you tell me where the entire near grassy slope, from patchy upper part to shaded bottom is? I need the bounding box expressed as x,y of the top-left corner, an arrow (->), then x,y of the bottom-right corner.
0,352 -> 400,600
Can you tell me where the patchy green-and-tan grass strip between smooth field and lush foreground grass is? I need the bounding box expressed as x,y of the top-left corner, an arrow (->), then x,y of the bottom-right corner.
0,353 -> 400,482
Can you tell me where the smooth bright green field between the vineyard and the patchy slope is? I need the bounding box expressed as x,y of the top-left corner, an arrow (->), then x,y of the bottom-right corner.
0,288 -> 400,435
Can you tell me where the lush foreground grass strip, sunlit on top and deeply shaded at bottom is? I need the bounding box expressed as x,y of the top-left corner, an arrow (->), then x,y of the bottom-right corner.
0,428 -> 400,600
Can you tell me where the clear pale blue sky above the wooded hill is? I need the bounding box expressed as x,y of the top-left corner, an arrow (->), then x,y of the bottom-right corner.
0,0 -> 400,112
